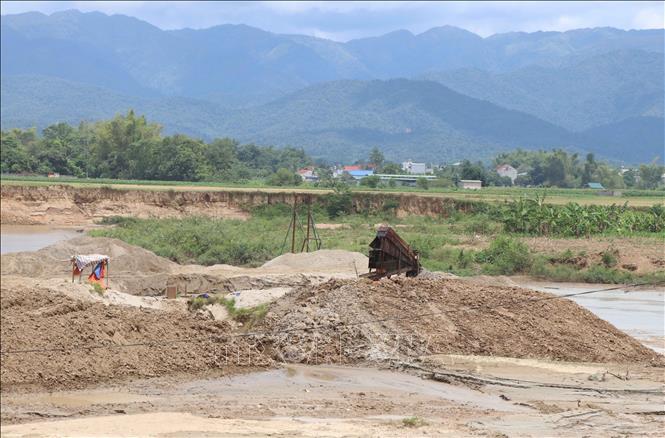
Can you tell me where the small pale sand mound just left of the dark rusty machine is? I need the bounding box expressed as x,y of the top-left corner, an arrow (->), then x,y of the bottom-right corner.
262,249 -> 367,273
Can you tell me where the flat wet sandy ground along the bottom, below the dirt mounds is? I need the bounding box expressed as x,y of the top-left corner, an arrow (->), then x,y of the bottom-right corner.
2,356 -> 665,437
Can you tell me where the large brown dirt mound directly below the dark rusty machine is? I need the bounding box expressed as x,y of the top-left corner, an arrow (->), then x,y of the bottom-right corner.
262,278 -> 664,364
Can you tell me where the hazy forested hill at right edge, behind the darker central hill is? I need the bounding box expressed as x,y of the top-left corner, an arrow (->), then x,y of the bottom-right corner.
421,50 -> 665,131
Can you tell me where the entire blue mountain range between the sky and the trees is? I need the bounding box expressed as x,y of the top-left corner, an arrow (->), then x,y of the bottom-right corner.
0,11 -> 665,162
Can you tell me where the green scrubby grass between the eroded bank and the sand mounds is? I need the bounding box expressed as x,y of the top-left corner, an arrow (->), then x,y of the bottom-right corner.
91,204 -> 665,283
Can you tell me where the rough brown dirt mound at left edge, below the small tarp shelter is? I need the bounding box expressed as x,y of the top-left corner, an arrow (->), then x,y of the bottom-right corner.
0,287 -> 271,391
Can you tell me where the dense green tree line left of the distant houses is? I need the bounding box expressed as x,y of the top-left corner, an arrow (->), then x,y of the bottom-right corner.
0,111 -> 312,183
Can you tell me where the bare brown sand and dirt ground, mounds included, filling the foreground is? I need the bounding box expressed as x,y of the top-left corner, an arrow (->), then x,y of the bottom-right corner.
0,237 -> 665,437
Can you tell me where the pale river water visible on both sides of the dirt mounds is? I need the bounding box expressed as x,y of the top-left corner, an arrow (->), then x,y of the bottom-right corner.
0,225 -> 665,354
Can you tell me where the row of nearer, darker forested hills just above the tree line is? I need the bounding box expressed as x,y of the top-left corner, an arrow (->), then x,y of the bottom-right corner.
0,76 -> 663,162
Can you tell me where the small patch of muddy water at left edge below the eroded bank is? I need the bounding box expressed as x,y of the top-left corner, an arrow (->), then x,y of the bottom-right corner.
0,225 -> 81,254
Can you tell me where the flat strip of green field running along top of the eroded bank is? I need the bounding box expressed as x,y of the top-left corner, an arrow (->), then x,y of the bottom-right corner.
2,176 -> 665,207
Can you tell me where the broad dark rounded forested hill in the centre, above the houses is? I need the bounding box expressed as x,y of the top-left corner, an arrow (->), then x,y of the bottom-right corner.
217,79 -> 574,161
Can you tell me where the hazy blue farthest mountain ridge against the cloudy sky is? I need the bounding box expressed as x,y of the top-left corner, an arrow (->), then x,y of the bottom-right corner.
2,10 -> 665,104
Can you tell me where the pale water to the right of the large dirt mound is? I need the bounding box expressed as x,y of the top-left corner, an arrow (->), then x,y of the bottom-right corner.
524,283 -> 665,354
